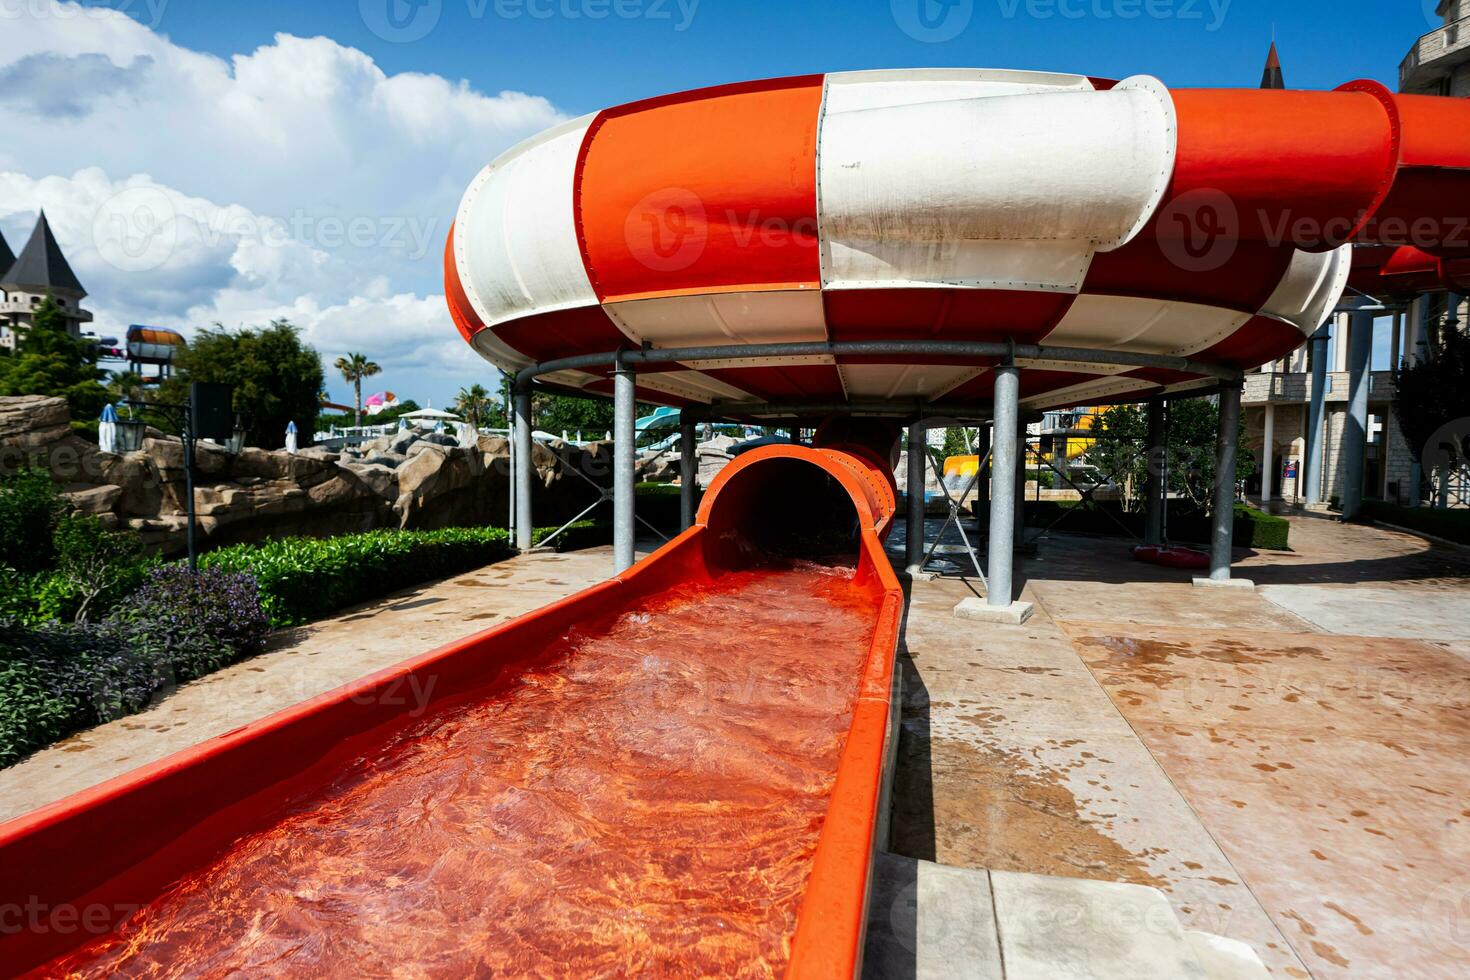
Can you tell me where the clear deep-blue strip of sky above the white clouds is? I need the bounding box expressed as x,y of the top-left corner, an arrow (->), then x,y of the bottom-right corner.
111,0 -> 1438,113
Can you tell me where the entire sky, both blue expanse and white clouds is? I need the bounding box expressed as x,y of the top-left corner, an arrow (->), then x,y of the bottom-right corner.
0,0 -> 1436,404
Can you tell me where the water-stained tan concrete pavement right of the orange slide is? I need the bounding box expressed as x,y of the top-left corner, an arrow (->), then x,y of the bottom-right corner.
895,519 -> 1470,977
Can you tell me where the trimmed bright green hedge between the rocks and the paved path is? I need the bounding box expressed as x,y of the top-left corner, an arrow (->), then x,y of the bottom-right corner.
200,527 -> 510,626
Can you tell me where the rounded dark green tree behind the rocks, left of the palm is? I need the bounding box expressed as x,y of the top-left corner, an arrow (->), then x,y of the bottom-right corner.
162,320 -> 325,450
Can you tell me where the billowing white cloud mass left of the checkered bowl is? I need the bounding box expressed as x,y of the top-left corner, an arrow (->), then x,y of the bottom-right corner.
0,0 -> 562,398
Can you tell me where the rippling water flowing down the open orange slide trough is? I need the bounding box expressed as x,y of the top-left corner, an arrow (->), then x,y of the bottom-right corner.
46,564 -> 873,977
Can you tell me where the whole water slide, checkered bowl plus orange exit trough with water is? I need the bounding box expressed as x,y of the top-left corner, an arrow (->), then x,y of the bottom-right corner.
0,69 -> 1470,977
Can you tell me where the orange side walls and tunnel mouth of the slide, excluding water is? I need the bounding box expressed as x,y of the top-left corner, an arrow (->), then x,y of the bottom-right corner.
0,445 -> 903,977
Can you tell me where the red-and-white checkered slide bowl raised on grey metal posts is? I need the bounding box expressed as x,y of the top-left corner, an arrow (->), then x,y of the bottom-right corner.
445,69 -> 1470,410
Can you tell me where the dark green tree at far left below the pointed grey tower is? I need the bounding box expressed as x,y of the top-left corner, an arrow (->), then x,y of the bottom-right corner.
0,292 -> 107,422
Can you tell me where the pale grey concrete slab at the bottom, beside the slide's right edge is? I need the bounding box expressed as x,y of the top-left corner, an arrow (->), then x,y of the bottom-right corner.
863,854 -> 1269,980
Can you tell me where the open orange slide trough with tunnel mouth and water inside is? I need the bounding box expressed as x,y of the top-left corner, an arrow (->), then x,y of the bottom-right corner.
0,445 -> 903,977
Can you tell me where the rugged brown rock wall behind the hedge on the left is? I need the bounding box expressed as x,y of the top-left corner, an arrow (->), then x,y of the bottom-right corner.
0,395 -> 612,554
